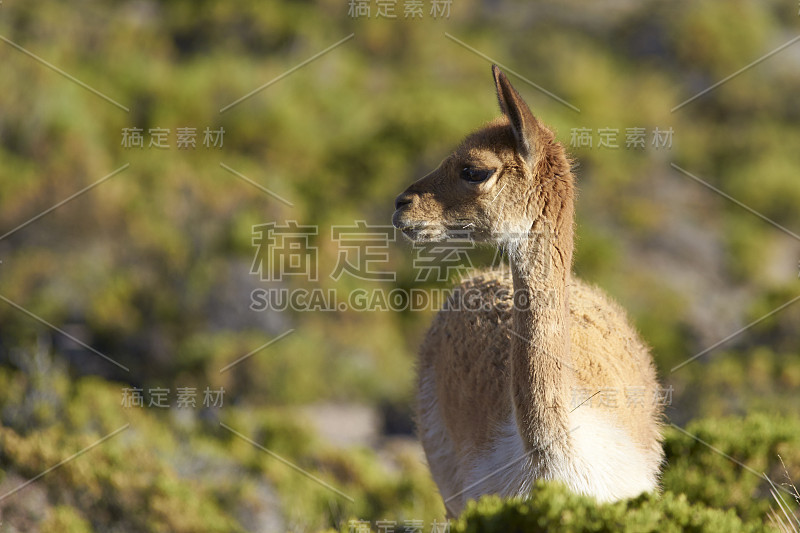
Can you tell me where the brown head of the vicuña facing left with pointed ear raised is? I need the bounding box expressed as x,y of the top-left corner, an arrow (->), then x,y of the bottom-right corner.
392,66 -> 572,245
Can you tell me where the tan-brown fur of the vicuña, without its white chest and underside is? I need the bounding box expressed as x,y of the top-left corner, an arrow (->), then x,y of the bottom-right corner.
393,67 -> 663,514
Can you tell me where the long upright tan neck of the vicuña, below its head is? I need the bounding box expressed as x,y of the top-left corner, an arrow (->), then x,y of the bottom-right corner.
511,167 -> 574,452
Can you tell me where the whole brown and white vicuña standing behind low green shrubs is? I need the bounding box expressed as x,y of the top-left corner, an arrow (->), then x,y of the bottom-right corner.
393,66 -> 663,516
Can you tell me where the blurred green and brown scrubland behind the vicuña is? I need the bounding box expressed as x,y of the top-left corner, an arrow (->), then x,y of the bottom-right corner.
0,0 -> 800,532
